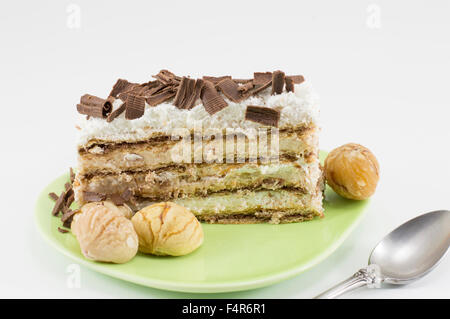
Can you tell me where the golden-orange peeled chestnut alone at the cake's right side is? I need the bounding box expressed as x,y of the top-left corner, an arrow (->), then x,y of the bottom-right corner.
324,143 -> 380,200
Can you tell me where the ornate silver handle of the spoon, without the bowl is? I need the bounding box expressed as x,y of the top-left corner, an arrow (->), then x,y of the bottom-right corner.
314,264 -> 382,299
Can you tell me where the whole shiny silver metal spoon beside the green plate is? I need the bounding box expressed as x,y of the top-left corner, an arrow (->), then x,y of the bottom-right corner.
315,210 -> 450,299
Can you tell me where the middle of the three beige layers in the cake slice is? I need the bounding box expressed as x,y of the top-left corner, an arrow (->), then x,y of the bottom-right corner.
76,161 -> 322,200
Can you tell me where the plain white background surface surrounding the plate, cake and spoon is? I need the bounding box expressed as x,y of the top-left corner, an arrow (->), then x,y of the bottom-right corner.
0,0 -> 450,298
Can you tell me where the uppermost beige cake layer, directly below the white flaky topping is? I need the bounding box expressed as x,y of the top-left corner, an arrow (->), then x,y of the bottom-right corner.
78,128 -> 318,175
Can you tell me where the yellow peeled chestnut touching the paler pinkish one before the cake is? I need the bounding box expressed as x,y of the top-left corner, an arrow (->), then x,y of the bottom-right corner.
131,202 -> 203,256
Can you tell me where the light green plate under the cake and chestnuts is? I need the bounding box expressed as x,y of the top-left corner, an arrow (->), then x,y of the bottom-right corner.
35,154 -> 367,293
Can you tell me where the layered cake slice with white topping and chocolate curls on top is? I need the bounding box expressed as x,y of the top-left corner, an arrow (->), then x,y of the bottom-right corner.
73,70 -> 323,224
